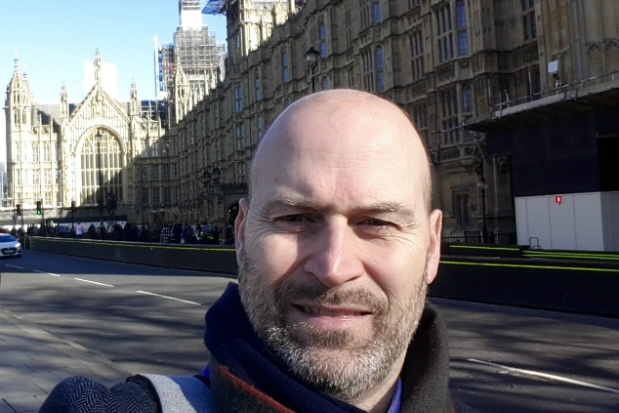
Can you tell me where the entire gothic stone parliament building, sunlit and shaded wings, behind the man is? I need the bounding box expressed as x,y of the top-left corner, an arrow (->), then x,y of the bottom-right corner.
5,0 -> 619,242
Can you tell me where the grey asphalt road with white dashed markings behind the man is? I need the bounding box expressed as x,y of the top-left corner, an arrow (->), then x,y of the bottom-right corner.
0,251 -> 619,413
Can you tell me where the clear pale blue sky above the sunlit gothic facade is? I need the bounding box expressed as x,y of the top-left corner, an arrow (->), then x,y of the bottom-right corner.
0,0 -> 226,104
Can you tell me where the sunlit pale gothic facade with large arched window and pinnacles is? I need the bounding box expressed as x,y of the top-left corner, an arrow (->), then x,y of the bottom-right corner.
5,52 -> 163,216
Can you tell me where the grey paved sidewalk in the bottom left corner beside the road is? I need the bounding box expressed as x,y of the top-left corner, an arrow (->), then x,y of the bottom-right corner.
0,309 -> 131,413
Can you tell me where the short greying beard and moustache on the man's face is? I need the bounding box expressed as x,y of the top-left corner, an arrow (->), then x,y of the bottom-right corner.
239,244 -> 427,402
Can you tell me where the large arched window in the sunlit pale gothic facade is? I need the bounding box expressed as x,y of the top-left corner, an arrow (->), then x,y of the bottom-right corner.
81,130 -> 123,206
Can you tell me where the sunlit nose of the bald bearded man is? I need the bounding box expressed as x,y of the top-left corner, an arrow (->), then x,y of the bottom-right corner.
304,220 -> 364,287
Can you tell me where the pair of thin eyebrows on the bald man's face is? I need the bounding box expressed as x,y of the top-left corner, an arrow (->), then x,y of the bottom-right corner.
261,197 -> 416,221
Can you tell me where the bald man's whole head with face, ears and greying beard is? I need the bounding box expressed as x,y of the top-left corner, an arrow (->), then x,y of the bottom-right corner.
236,90 -> 442,409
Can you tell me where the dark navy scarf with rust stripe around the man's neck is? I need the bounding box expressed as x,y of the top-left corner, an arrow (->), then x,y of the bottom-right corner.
204,283 -> 452,413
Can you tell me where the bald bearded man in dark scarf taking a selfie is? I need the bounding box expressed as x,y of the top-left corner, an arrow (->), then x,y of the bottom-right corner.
41,90 -> 470,413
